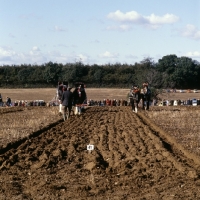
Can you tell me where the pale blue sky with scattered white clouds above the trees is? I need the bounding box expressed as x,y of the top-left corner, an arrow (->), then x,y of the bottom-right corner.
0,0 -> 200,66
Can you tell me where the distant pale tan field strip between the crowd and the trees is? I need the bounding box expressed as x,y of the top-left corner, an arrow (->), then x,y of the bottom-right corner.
0,88 -> 200,102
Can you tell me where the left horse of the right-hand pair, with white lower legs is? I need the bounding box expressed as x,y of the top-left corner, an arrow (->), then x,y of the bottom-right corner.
129,85 -> 140,113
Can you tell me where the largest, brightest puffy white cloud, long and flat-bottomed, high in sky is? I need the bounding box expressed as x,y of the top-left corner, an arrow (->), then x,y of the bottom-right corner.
107,10 -> 179,28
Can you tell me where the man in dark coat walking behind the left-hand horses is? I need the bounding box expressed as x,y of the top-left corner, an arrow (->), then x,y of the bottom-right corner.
61,86 -> 73,121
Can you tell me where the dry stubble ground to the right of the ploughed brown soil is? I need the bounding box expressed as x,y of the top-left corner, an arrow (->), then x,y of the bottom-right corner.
145,106 -> 200,157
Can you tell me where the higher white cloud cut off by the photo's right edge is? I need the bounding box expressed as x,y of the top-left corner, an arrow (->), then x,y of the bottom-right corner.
182,24 -> 200,40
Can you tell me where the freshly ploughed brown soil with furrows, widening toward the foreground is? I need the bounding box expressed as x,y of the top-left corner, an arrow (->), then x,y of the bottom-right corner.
0,107 -> 200,200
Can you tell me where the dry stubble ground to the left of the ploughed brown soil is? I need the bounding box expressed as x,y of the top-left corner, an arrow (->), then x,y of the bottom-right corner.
0,106 -> 61,149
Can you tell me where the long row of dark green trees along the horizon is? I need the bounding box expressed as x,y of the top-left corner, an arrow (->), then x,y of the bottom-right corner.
0,54 -> 200,89
